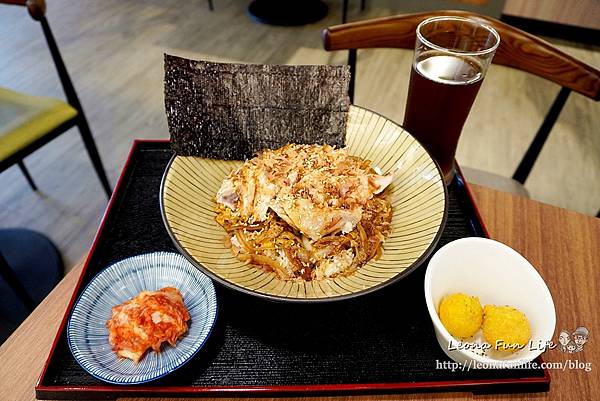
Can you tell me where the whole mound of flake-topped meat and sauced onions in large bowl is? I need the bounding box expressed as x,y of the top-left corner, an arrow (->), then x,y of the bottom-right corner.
215,145 -> 393,281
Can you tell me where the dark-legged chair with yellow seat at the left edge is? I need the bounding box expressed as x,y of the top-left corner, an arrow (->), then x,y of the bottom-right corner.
0,0 -> 112,197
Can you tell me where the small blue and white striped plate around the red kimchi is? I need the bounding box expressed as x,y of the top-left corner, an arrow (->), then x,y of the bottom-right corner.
67,252 -> 217,384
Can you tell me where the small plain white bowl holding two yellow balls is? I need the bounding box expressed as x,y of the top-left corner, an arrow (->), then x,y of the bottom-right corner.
425,237 -> 556,368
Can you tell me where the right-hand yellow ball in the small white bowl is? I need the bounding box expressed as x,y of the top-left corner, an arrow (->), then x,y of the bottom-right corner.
483,305 -> 531,352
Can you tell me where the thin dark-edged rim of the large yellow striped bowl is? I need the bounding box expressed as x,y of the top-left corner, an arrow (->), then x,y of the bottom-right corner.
159,105 -> 448,303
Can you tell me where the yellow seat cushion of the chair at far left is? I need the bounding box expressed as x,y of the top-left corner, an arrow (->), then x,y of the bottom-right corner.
0,87 -> 77,161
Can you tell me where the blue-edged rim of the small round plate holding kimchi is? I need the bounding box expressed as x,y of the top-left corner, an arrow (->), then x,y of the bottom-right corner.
67,251 -> 219,386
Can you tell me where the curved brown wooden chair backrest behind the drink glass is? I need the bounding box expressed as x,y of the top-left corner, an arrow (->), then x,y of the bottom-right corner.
323,10 -> 600,100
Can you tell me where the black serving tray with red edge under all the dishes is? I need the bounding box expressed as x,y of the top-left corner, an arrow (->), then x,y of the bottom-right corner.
36,141 -> 550,399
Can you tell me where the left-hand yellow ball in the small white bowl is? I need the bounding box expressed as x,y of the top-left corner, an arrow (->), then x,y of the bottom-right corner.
439,293 -> 483,339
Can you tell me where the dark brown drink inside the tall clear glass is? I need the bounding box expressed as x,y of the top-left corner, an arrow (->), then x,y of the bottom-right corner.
403,50 -> 484,183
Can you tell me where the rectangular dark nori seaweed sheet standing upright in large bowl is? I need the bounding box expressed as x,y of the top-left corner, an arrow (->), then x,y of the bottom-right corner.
165,54 -> 350,160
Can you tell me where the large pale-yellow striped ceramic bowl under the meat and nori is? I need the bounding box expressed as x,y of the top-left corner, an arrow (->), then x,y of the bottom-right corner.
161,106 -> 448,302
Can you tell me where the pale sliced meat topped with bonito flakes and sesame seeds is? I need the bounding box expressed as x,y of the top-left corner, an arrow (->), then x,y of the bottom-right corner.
217,145 -> 393,240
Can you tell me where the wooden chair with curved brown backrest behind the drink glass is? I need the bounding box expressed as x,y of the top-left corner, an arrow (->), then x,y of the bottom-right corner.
323,11 -> 600,200
